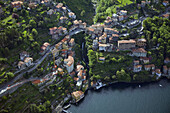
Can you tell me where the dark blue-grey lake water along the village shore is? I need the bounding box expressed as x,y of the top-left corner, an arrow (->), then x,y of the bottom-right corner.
68,79 -> 170,113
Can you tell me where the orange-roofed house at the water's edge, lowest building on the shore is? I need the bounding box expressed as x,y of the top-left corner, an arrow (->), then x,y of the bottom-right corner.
71,91 -> 84,103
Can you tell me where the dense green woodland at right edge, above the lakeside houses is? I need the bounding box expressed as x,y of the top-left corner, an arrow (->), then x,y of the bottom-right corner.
143,16 -> 170,66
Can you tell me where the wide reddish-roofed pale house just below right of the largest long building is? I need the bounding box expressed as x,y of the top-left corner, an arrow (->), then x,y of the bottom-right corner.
132,48 -> 147,57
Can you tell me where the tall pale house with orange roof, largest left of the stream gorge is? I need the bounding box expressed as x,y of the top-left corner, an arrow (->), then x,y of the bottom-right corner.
64,56 -> 74,73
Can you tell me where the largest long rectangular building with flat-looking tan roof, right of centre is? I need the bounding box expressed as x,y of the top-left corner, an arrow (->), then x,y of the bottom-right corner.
118,40 -> 136,50
